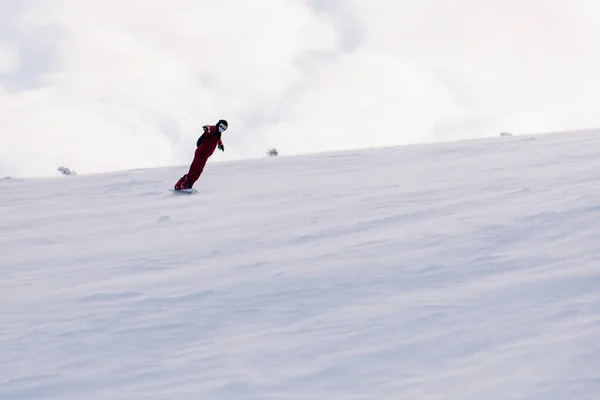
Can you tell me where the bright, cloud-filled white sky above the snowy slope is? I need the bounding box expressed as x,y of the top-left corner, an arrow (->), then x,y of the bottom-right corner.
0,0 -> 600,176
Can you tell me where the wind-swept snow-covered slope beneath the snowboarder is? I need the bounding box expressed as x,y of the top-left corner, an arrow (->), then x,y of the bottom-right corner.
0,131 -> 600,400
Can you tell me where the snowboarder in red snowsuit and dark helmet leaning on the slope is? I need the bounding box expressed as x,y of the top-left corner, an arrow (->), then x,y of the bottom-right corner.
175,119 -> 228,190
